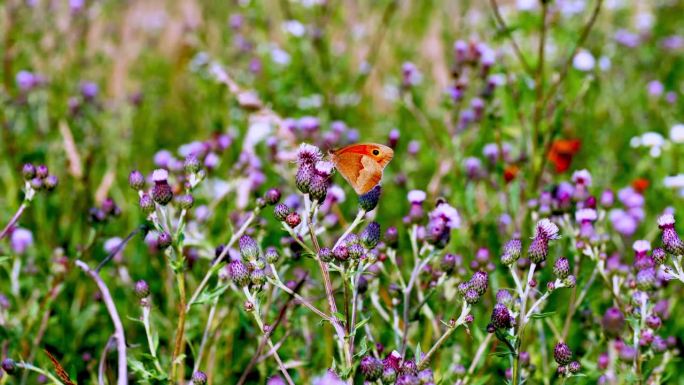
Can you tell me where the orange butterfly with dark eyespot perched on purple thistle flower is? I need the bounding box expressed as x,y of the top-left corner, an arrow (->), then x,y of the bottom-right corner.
330,143 -> 394,195
